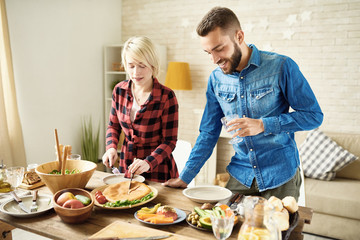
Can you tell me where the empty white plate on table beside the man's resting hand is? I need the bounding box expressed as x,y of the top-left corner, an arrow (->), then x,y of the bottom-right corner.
183,186 -> 232,203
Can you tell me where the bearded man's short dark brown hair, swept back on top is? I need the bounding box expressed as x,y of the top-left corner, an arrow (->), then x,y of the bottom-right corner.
196,7 -> 241,37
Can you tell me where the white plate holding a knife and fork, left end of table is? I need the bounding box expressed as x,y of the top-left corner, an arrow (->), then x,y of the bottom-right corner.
0,194 -> 53,218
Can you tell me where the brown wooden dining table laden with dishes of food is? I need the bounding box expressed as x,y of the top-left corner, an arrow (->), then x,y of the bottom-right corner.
0,171 -> 312,240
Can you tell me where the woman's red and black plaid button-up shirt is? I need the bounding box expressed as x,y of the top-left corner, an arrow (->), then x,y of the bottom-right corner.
106,79 -> 179,182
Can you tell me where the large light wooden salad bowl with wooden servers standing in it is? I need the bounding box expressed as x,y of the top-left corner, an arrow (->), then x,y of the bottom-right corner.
35,160 -> 97,193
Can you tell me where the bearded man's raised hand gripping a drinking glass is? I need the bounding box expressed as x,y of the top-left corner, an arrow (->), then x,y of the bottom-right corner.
227,117 -> 264,138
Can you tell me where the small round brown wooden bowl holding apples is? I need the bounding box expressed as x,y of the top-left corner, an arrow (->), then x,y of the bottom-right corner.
53,188 -> 94,223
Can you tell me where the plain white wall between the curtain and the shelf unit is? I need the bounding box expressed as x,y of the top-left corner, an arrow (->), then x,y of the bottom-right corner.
6,0 -> 121,163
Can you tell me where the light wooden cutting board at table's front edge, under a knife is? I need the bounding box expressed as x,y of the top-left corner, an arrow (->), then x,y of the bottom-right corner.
89,221 -> 195,240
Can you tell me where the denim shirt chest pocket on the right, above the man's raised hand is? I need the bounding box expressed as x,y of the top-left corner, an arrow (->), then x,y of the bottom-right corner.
250,87 -> 275,118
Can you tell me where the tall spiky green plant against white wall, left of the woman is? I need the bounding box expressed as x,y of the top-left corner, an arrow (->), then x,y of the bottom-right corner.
81,117 -> 100,170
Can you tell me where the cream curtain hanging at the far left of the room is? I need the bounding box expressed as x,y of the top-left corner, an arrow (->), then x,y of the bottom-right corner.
0,0 -> 26,167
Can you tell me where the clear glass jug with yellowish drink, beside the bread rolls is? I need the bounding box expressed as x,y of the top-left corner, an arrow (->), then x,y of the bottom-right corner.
238,196 -> 281,240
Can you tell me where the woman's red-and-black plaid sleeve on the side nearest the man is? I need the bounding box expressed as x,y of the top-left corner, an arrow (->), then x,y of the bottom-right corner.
146,91 -> 179,171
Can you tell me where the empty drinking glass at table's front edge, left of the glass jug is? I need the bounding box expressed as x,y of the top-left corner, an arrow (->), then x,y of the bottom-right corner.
210,214 -> 234,240
